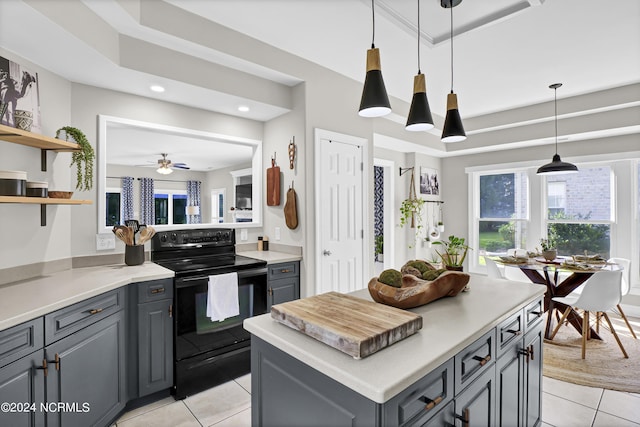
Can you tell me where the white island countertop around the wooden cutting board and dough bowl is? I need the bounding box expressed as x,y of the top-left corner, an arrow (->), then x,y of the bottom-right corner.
244,275 -> 546,403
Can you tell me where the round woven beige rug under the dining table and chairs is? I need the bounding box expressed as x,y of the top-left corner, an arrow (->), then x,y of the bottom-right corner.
543,316 -> 640,393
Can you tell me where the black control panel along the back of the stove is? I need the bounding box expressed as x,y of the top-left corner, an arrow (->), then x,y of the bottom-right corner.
152,228 -> 236,250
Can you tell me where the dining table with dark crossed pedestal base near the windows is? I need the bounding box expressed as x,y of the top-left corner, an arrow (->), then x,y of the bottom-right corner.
491,256 -> 622,340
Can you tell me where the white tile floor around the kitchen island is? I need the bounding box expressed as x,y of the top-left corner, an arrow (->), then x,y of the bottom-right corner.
116,316 -> 640,427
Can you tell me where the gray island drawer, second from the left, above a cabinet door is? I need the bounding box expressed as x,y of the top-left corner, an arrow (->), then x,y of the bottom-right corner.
454,328 -> 496,396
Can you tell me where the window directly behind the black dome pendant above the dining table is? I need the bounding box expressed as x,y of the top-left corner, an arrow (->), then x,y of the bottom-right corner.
546,166 -> 613,258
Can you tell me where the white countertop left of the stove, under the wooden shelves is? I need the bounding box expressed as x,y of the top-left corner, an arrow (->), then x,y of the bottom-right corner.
0,262 -> 174,331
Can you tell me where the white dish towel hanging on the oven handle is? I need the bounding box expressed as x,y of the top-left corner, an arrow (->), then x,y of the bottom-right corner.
207,273 -> 240,322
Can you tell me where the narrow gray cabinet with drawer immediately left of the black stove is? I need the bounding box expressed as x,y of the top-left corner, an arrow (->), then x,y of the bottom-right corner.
129,279 -> 173,398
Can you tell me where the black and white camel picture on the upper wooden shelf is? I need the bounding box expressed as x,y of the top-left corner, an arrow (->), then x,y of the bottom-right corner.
0,56 -> 41,133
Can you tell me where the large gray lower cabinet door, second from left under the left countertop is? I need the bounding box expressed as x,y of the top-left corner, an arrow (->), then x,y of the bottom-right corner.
45,298 -> 127,427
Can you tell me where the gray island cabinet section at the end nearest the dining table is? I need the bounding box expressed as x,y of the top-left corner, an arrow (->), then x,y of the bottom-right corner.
496,300 -> 542,427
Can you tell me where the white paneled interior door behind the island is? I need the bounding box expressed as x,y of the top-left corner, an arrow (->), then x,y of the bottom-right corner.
316,132 -> 366,294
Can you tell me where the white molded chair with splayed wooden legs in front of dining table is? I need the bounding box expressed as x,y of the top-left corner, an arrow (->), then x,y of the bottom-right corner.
549,270 -> 629,359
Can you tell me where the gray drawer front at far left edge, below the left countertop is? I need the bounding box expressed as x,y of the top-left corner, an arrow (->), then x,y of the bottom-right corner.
0,317 -> 44,366
